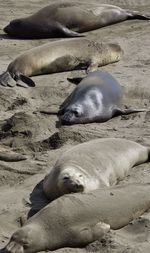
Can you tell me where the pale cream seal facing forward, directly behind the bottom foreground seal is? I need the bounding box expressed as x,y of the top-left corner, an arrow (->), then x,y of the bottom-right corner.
43,138 -> 150,200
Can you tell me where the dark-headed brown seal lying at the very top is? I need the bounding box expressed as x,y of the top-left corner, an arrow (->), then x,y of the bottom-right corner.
4,1 -> 150,38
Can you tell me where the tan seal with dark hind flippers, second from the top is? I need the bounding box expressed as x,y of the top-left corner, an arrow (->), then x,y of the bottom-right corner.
0,39 -> 123,86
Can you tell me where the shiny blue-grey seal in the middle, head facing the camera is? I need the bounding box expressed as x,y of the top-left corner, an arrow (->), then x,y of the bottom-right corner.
58,70 -> 146,125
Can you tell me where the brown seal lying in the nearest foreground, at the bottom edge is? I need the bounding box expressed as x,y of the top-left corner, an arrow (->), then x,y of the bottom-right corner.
4,184 -> 150,253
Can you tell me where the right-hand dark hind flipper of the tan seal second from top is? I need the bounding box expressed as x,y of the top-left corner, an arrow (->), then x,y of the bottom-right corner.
15,74 -> 35,88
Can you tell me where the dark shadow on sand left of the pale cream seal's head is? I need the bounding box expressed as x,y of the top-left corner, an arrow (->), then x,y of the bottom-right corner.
27,180 -> 50,219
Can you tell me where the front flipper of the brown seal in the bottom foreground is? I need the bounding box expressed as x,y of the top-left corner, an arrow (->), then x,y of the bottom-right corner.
76,222 -> 110,246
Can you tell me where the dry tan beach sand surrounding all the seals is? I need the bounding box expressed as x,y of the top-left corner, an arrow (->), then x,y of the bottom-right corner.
0,0 -> 150,253
